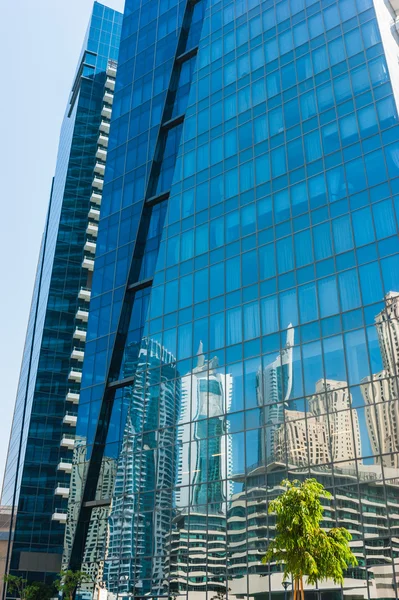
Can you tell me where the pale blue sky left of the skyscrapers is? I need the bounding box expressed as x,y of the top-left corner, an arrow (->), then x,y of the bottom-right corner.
0,0 -> 124,486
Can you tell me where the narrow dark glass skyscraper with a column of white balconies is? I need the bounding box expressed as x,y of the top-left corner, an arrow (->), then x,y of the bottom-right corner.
2,2 -> 122,596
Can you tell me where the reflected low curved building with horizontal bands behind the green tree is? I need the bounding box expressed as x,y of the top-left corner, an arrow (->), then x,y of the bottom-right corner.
228,464 -> 399,599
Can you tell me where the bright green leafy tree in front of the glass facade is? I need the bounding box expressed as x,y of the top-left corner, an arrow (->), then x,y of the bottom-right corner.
262,479 -> 357,600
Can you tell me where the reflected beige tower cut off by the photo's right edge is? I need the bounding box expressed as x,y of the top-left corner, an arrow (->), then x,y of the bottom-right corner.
361,292 -> 399,468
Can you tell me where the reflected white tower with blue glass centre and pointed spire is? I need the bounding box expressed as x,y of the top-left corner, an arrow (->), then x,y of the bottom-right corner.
169,343 -> 233,593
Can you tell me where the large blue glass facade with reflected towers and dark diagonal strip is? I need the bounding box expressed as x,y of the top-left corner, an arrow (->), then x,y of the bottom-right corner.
66,0 -> 399,600
